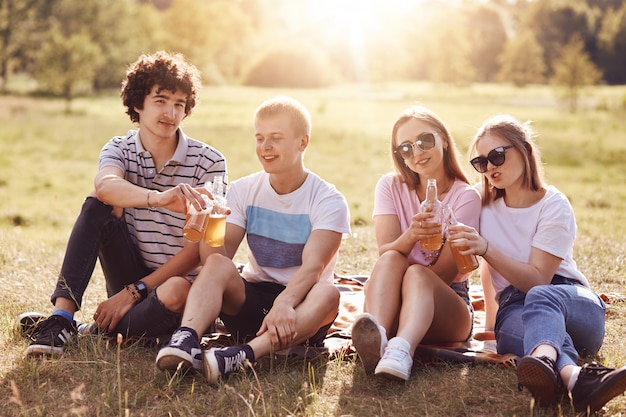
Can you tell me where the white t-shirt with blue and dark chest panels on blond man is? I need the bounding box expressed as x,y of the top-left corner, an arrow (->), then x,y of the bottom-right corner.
226,171 -> 350,285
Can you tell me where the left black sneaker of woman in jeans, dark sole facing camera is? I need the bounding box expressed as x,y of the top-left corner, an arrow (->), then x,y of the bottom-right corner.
517,356 -> 563,407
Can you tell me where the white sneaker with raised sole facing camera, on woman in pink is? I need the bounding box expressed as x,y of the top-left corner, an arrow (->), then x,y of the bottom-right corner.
352,313 -> 387,374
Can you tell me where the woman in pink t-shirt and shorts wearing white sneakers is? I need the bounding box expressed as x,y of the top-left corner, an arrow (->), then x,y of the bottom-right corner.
352,106 -> 480,381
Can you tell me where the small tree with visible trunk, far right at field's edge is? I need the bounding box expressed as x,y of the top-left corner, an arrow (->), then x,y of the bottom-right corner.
552,36 -> 602,112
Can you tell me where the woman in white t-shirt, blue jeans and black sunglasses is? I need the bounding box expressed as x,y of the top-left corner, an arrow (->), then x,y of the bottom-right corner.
450,115 -> 626,413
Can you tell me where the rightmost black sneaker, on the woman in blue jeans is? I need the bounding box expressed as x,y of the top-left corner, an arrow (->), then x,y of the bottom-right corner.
571,362 -> 626,415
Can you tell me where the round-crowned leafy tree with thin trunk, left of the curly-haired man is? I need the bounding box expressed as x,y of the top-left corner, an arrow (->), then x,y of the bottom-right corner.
34,24 -> 101,112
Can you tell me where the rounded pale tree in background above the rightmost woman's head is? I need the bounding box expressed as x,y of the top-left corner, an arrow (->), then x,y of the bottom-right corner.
499,31 -> 546,87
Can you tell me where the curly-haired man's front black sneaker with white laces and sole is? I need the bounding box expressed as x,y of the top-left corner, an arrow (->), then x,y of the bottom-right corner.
26,314 -> 76,356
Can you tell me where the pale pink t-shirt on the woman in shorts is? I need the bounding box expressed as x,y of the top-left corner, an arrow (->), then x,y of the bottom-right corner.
372,173 -> 481,282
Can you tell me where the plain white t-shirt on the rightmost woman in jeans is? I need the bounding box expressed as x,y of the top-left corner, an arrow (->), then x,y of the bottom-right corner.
480,186 -> 589,298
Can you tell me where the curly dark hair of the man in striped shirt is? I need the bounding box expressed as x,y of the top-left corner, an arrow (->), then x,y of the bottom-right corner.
120,51 -> 202,123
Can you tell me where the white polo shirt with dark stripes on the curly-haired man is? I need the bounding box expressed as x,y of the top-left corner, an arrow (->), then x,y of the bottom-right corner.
98,129 -> 228,270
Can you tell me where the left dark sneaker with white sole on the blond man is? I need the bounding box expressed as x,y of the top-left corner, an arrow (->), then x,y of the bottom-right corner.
156,329 -> 202,372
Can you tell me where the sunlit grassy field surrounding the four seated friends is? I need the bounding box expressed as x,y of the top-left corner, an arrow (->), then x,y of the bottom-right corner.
0,84 -> 626,416
